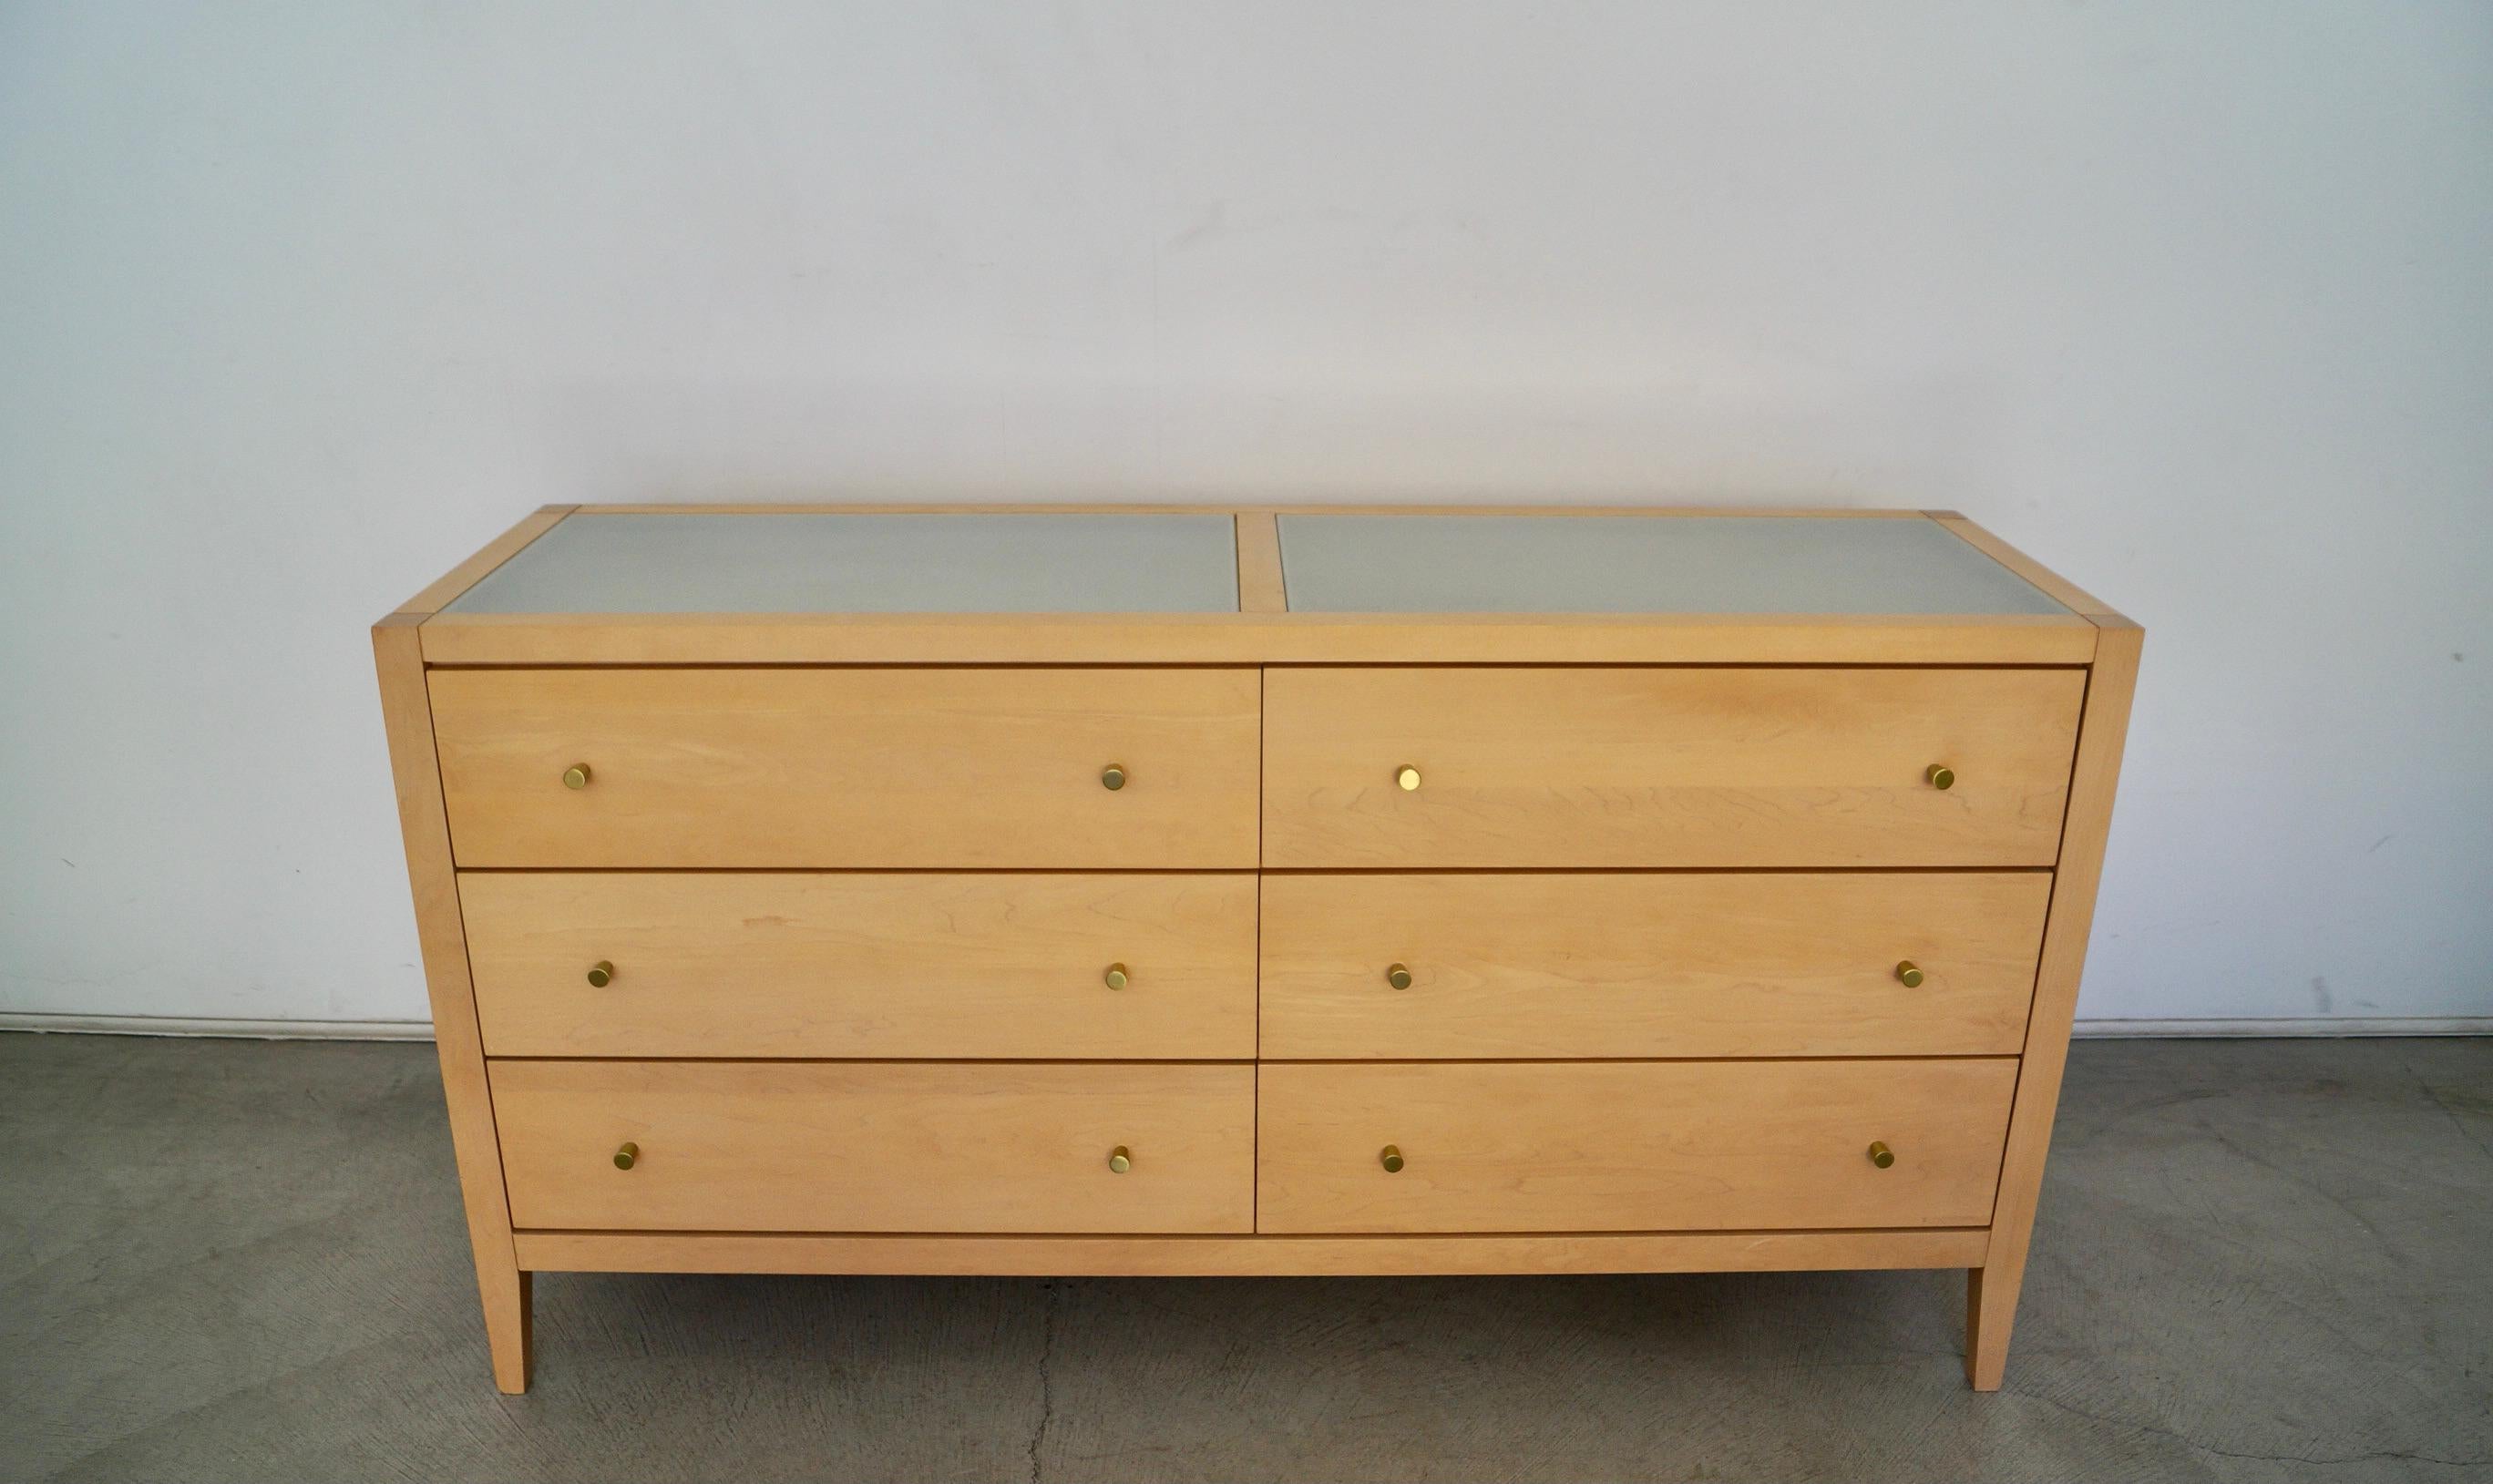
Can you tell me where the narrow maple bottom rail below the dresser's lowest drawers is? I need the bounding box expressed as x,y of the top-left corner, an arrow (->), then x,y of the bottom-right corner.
514,1227 -> 1992,1277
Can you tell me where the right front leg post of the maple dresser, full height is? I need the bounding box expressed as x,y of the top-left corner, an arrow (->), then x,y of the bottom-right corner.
1965,619 -> 2147,1392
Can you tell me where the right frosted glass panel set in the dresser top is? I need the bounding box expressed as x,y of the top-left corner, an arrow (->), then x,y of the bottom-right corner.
1281,517 -> 2067,614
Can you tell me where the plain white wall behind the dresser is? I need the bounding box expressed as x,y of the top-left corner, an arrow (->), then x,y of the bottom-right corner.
0,0 -> 2493,1020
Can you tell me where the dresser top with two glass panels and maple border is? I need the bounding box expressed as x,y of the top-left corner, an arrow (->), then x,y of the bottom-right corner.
394,507 -> 2127,663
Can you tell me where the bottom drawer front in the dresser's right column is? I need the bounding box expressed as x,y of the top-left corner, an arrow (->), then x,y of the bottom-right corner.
1257,1058 -> 2016,1232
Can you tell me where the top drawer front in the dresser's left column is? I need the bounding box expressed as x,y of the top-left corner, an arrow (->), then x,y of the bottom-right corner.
431,669 -> 1259,868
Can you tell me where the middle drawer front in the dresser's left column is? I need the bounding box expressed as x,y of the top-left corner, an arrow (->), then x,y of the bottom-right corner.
458,870 -> 1257,1060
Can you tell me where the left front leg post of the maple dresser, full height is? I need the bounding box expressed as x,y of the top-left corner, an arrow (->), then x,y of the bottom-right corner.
372,614 -> 528,1394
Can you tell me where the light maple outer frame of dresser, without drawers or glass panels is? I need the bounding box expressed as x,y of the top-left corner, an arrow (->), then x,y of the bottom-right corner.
374,504 -> 2144,1392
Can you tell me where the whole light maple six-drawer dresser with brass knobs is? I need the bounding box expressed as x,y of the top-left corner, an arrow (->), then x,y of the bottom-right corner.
374,507 -> 2141,1392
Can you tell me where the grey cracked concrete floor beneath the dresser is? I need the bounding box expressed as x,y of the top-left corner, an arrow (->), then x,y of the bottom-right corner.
0,1035 -> 2493,1481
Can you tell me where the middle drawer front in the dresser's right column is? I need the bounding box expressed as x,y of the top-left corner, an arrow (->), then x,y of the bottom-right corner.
1261,870 -> 2052,1060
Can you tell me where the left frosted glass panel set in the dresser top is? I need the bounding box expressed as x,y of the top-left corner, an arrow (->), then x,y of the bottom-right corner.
444,514 -> 1239,614
